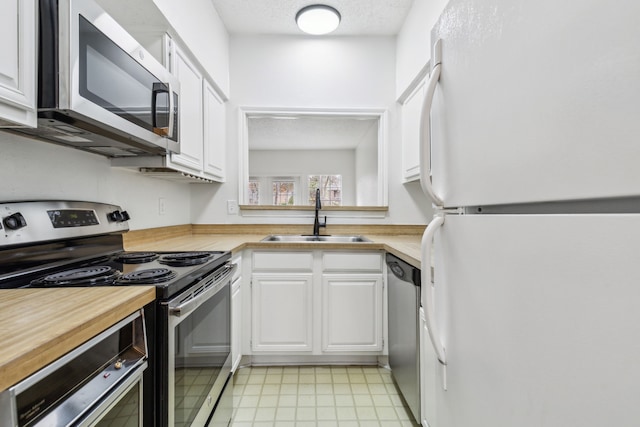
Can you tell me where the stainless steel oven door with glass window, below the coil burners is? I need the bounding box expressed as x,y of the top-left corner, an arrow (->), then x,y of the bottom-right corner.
166,264 -> 237,426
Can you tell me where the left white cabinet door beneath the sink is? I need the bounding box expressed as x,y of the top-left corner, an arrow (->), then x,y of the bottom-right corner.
251,274 -> 313,352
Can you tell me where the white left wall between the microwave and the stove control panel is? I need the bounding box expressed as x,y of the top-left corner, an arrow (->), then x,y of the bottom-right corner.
0,132 -> 191,230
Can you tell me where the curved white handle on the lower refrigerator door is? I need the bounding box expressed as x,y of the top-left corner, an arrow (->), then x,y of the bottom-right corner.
420,215 -> 447,365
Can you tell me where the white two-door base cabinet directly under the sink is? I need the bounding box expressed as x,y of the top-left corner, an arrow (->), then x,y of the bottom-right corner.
251,250 -> 384,356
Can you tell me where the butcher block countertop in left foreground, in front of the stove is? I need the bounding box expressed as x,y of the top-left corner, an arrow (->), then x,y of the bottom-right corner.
0,286 -> 155,391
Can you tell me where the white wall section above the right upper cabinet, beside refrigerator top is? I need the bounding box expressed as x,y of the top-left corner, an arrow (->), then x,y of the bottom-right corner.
396,0 -> 448,99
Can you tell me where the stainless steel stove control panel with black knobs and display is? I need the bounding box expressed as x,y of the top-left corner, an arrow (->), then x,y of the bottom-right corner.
0,201 -> 130,246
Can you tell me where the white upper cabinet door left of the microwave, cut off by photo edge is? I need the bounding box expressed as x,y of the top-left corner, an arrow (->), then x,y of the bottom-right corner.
0,0 -> 38,127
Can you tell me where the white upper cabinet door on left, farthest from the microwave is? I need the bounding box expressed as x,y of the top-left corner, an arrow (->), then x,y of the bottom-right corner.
203,80 -> 227,182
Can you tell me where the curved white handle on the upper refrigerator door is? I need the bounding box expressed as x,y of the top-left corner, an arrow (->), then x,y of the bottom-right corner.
420,39 -> 444,207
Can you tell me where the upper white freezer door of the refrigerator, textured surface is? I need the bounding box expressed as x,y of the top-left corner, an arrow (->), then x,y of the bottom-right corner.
423,0 -> 640,207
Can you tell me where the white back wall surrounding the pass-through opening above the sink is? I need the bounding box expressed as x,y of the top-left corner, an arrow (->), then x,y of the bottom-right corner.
192,35 -> 431,224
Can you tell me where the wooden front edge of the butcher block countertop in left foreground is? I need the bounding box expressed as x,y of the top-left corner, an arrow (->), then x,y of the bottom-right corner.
0,287 -> 155,391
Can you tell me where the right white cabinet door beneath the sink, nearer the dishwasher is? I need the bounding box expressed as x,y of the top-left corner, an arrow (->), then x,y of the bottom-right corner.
322,274 -> 383,352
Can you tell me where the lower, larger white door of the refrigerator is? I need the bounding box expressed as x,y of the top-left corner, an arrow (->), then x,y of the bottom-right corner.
434,215 -> 640,427
